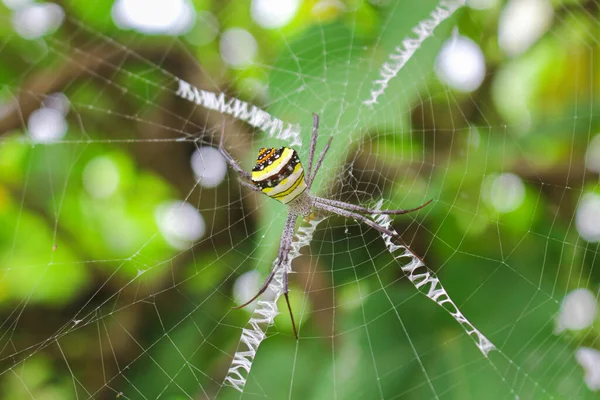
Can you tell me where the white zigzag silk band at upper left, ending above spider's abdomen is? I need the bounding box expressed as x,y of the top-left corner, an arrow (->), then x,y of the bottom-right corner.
175,79 -> 302,147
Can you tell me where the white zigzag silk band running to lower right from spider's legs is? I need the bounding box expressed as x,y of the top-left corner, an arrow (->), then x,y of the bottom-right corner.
372,200 -> 496,357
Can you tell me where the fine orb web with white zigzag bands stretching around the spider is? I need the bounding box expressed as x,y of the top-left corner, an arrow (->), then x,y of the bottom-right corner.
0,0 -> 600,399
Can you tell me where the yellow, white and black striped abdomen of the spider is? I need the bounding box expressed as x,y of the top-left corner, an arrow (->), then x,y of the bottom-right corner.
252,147 -> 307,204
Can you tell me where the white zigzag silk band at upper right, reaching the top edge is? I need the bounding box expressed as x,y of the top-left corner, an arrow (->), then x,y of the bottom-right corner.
363,0 -> 466,108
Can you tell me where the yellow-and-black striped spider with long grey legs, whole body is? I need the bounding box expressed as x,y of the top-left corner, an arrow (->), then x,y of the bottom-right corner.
219,114 -> 433,340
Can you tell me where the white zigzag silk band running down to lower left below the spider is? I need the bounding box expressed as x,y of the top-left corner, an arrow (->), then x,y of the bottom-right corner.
224,218 -> 324,392
